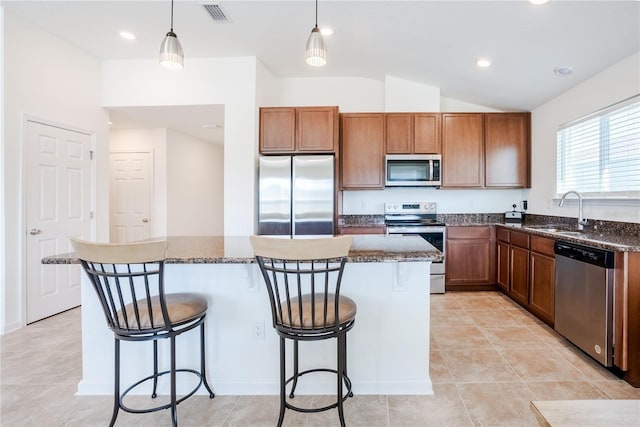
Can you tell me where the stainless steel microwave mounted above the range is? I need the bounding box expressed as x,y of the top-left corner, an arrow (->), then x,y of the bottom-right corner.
385,154 -> 442,187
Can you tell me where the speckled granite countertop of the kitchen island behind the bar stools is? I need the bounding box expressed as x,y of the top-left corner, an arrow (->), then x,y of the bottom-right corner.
42,235 -> 442,264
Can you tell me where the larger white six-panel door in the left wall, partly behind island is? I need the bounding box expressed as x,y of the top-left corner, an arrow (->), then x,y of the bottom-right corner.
24,121 -> 92,323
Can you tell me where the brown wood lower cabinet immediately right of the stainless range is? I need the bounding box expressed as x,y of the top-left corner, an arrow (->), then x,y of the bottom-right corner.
445,226 -> 496,290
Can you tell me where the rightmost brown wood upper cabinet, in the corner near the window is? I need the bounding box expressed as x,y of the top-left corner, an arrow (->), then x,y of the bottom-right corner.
484,113 -> 531,188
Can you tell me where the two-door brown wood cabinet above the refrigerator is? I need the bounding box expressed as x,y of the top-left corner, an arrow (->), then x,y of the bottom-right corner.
260,107 -> 338,154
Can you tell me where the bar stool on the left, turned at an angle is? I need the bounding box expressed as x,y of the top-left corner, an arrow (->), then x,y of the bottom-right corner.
71,238 -> 215,426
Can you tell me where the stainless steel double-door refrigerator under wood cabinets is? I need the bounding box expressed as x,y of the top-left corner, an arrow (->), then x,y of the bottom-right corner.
258,155 -> 335,238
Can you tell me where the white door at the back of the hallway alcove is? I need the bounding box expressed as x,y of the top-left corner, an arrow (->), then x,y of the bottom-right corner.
109,151 -> 152,243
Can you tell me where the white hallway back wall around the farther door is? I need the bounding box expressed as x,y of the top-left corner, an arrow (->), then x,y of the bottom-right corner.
110,128 -> 168,237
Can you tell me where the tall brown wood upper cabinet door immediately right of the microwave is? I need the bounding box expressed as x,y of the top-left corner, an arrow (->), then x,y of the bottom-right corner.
442,113 -> 484,188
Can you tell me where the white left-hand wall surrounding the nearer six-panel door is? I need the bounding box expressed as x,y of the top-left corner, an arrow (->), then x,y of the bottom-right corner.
0,10 -> 108,332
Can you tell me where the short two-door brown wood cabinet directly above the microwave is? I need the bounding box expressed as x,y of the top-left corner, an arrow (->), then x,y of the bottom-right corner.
385,113 -> 441,154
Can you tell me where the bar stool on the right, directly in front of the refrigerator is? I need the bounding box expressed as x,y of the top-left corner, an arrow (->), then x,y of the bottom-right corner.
251,236 -> 357,426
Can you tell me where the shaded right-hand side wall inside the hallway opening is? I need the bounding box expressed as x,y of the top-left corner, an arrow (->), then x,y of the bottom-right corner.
166,130 -> 224,236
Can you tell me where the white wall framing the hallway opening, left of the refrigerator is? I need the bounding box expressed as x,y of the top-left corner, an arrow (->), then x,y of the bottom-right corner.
98,57 -> 257,236
